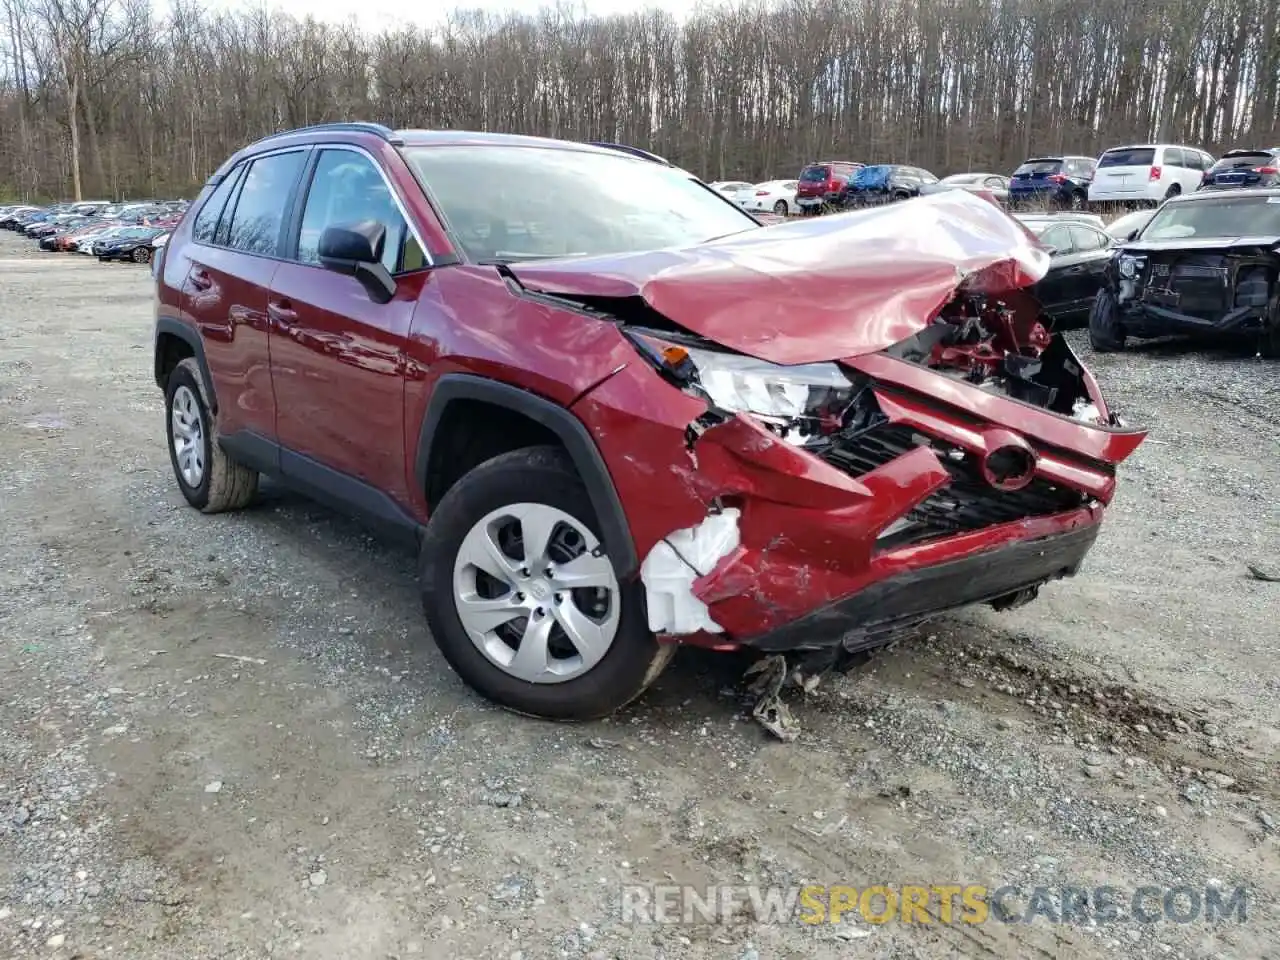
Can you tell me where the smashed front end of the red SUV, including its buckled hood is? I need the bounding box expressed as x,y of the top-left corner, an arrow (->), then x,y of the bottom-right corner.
513,192 -> 1144,659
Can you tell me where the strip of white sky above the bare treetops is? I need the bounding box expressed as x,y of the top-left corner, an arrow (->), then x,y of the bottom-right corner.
202,0 -> 730,32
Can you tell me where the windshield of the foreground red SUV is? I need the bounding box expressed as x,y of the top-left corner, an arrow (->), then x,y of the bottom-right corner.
404,145 -> 759,261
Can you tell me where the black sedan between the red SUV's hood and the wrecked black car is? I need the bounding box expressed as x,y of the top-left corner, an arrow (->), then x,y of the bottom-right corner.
1015,214 -> 1114,330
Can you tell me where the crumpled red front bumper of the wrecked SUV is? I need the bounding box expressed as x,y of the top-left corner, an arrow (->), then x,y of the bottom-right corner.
573,355 -> 1143,650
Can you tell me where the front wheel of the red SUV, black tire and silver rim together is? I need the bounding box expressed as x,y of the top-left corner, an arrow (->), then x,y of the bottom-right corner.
419,447 -> 676,721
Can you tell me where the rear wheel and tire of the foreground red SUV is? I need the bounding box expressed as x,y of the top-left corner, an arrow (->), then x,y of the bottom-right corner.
165,357 -> 259,513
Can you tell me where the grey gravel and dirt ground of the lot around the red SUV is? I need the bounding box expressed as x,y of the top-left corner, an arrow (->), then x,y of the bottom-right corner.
0,234 -> 1280,960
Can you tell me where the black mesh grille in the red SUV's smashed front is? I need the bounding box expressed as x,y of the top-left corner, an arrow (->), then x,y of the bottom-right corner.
822,424 -> 1085,544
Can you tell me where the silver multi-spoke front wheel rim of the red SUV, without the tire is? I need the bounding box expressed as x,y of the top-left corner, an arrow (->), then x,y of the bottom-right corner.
453,503 -> 622,684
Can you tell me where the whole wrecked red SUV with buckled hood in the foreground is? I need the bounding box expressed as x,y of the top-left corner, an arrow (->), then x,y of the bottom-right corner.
154,124 -> 1143,718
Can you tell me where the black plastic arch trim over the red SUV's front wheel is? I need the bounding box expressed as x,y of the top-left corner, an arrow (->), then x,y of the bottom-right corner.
413,374 -> 640,580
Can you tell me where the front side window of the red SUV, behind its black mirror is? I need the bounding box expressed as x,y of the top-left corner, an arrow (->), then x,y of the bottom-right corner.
298,150 -> 408,273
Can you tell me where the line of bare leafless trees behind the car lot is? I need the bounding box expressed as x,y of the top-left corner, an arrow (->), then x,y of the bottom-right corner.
0,0 -> 1280,198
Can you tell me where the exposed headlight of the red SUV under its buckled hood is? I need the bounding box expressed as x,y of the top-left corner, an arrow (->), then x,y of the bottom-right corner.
631,334 -> 858,434
